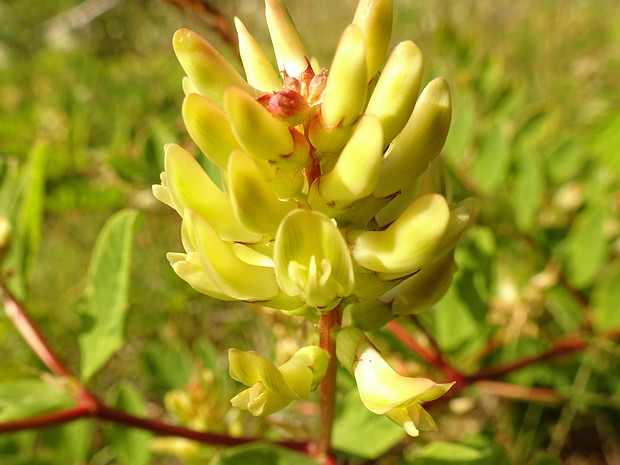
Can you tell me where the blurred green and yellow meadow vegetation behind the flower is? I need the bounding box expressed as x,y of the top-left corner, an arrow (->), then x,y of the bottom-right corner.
0,0 -> 620,465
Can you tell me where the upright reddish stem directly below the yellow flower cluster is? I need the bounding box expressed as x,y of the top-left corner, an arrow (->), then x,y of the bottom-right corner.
318,305 -> 342,463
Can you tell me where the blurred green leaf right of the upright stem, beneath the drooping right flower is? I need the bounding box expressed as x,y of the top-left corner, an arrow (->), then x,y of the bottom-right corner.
332,389 -> 406,459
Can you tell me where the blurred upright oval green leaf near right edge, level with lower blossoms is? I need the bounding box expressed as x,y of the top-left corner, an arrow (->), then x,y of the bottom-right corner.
565,205 -> 608,287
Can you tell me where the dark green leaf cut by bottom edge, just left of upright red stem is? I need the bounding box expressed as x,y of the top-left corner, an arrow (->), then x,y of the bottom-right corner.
209,443 -> 316,465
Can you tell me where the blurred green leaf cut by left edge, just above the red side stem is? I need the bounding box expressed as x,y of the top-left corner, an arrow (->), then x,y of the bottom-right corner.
0,379 -> 75,422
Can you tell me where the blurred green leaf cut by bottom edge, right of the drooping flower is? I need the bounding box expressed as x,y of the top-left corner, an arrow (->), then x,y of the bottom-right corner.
412,434 -> 510,465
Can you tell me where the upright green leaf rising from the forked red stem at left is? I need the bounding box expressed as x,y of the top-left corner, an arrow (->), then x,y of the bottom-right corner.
79,210 -> 136,380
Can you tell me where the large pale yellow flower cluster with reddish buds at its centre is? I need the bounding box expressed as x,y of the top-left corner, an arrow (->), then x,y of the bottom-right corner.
153,0 -> 472,434
